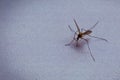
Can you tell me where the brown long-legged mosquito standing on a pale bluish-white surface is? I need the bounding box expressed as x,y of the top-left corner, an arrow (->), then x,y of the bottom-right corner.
65,19 -> 108,61
